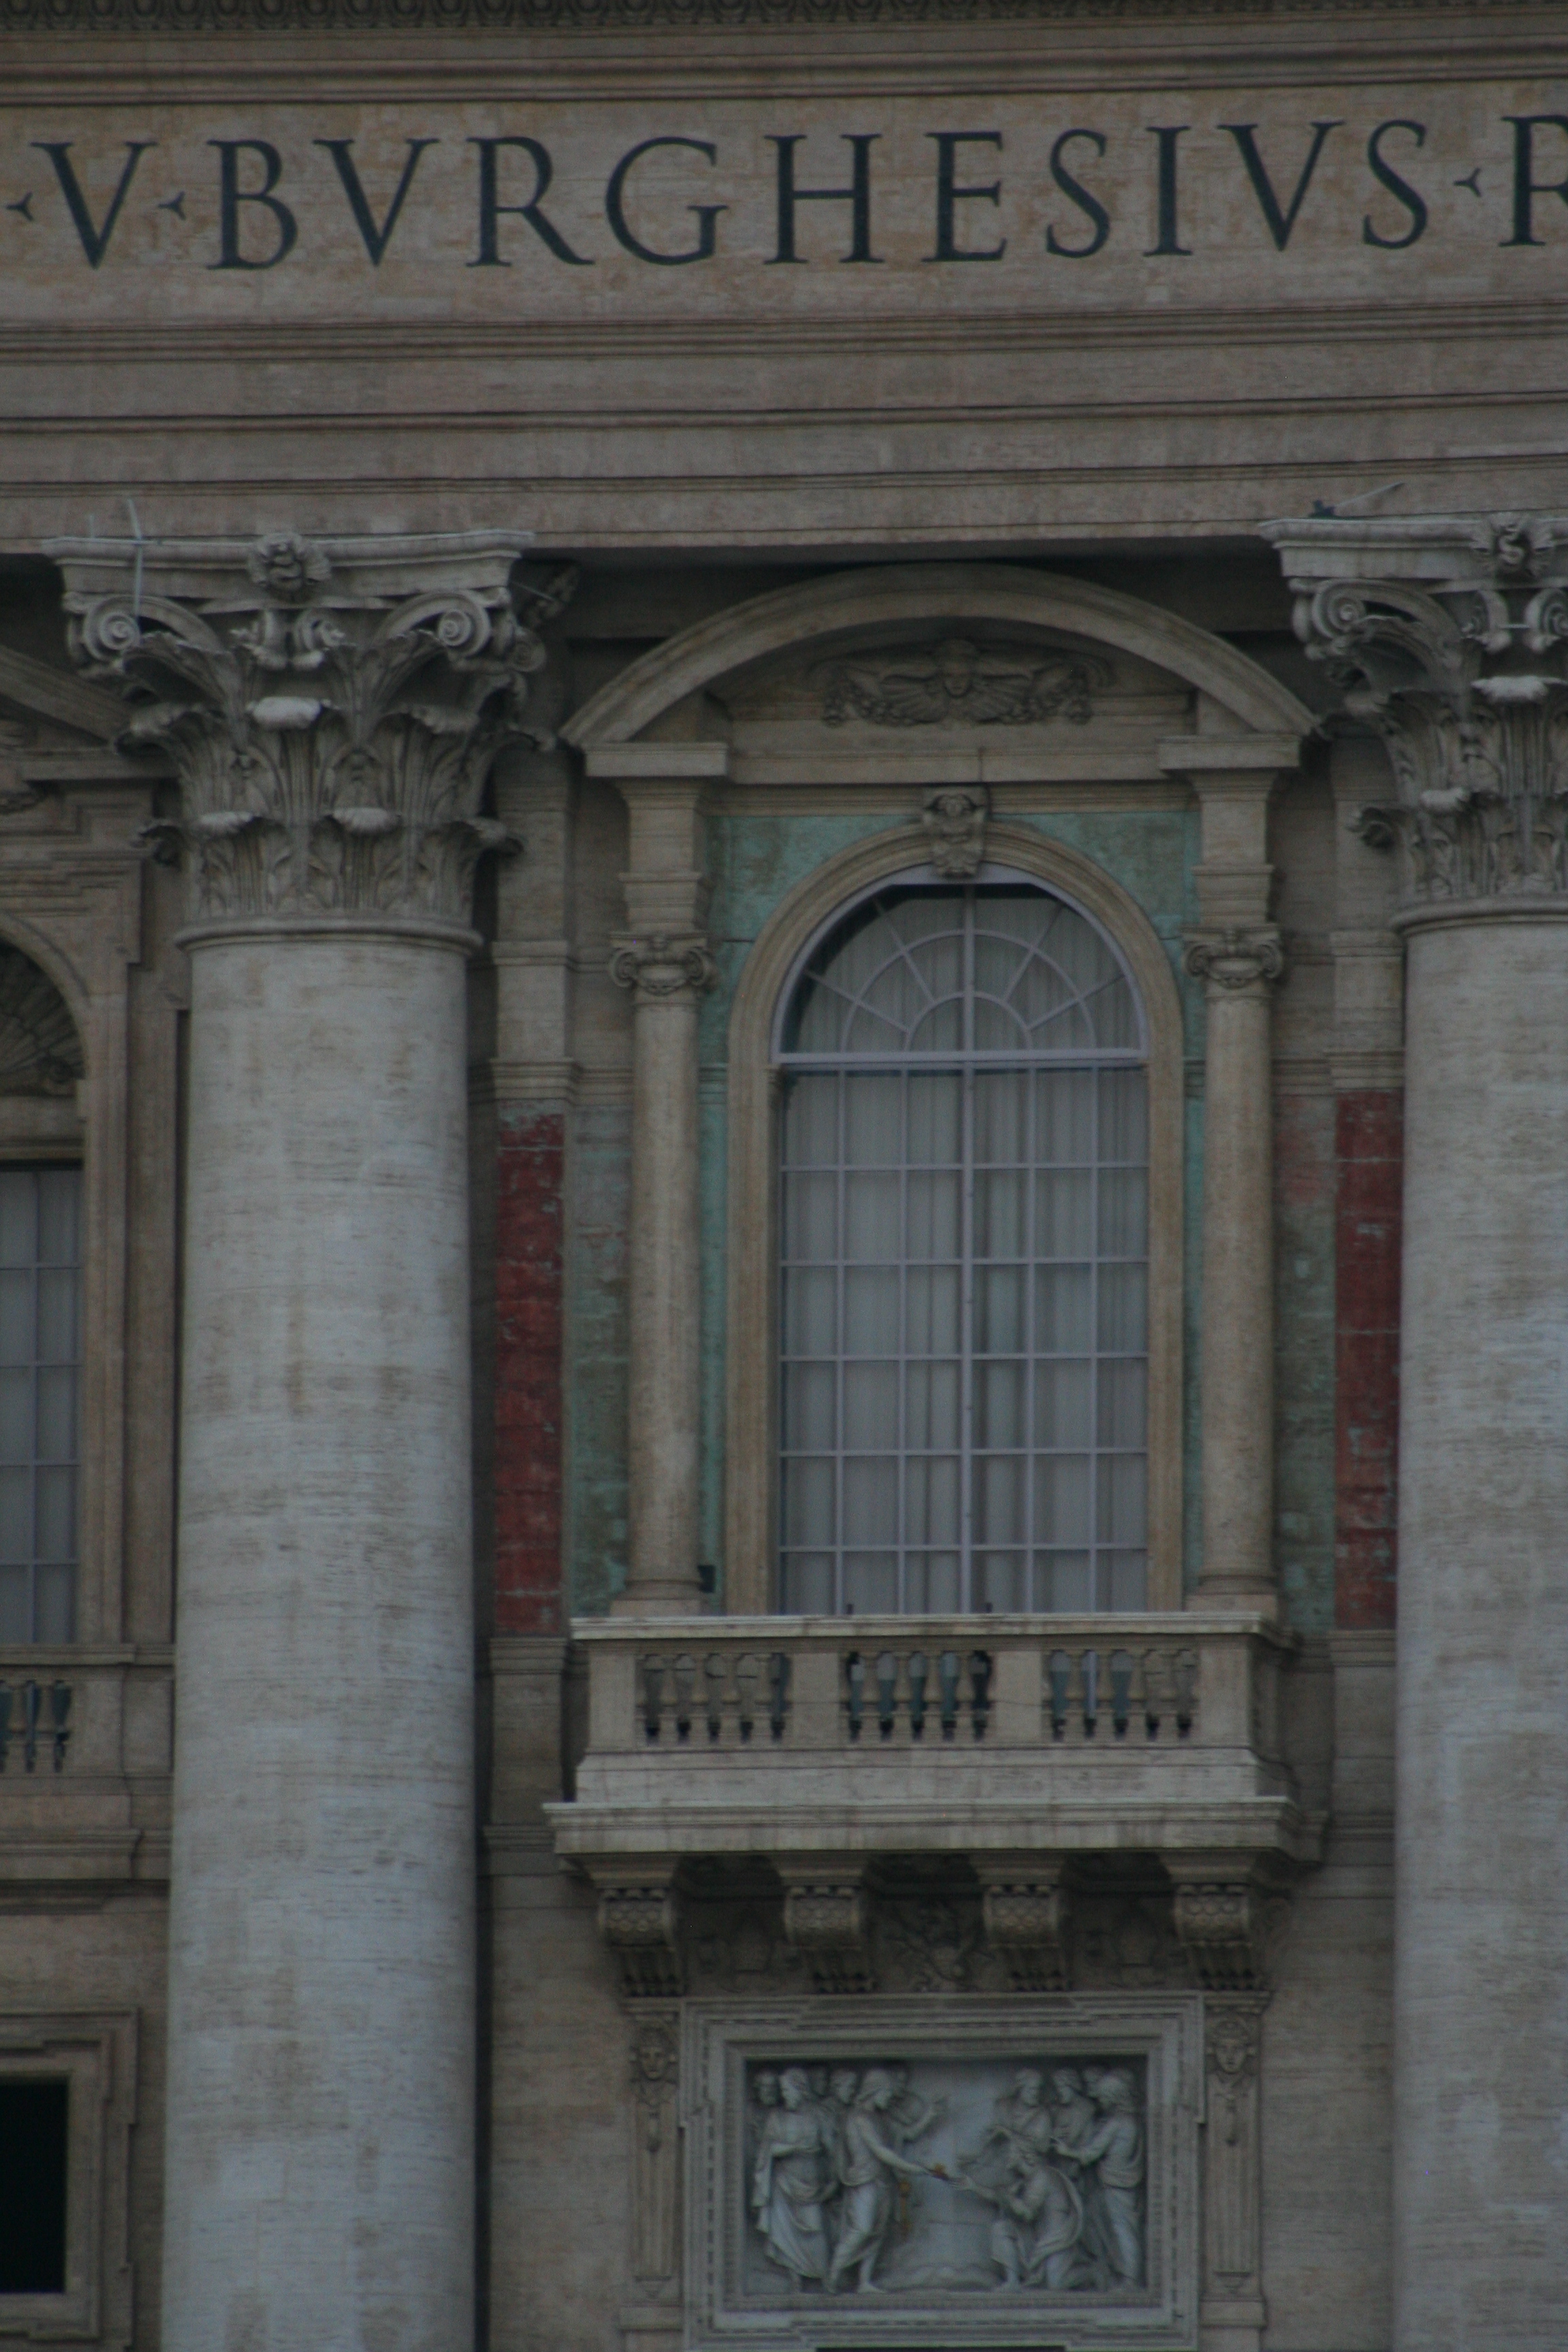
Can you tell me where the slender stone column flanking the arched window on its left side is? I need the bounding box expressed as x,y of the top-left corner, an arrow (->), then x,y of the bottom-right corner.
588,743 -> 726,1616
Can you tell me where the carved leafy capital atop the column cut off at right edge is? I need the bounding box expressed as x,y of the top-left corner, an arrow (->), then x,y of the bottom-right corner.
1262,515 -> 1568,910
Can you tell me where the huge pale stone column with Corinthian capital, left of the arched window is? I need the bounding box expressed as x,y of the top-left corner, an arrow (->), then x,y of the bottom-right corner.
50,532 -> 540,2352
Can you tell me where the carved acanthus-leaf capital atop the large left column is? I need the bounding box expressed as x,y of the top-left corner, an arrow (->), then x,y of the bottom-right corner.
47,532 -> 581,924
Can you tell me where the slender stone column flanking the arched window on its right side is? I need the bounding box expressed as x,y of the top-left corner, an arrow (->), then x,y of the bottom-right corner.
1161,736 -> 1298,1609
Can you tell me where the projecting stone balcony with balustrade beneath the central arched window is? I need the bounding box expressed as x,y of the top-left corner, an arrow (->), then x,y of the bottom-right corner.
550,1614 -> 1321,1877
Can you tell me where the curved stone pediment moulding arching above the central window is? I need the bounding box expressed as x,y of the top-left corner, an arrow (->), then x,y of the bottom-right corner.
562,564 -> 1316,753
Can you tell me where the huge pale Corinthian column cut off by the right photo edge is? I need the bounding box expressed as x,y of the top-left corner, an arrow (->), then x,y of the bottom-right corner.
1267,515 -> 1568,2352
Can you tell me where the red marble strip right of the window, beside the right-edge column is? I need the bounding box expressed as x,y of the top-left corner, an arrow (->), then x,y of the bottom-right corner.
1335,1092 -> 1403,1628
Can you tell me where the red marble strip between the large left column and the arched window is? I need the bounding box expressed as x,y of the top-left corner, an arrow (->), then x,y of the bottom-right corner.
496,1110 -> 566,1632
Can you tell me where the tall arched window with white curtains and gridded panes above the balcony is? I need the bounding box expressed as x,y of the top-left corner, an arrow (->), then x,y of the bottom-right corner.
776,868 -> 1149,1614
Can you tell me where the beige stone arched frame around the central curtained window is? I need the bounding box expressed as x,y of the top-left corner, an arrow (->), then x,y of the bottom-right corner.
724,826 -> 1182,1616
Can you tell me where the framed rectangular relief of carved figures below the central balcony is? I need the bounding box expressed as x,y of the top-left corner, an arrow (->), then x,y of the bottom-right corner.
682,1995 -> 1204,2352
